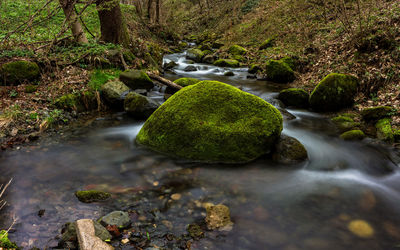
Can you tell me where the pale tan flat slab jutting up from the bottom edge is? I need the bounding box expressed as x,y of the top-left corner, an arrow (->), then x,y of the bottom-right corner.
76,219 -> 114,250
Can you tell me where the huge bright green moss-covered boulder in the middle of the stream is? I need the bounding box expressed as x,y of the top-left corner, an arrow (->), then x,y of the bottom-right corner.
136,81 -> 282,163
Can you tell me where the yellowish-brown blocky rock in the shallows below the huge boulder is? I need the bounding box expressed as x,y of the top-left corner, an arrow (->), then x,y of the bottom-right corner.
206,204 -> 233,230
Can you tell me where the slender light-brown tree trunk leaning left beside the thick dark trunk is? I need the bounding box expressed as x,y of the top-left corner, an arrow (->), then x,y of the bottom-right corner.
60,0 -> 88,43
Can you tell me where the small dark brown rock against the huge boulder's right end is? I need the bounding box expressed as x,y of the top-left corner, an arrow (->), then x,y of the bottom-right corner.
272,135 -> 308,164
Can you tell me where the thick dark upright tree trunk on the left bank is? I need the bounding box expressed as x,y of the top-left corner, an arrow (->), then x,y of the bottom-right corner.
96,0 -> 130,46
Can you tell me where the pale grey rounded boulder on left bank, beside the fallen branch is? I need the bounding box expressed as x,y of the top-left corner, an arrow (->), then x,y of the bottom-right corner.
100,80 -> 129,110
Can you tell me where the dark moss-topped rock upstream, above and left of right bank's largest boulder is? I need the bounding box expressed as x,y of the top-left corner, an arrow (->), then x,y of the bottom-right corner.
265,60 -> 296,83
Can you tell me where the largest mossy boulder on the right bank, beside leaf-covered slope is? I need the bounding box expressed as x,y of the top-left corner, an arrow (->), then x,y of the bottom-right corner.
310,73 -> 358,112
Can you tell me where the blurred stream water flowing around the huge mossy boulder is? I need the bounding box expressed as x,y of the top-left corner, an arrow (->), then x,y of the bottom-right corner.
0,51 -> 400,250
